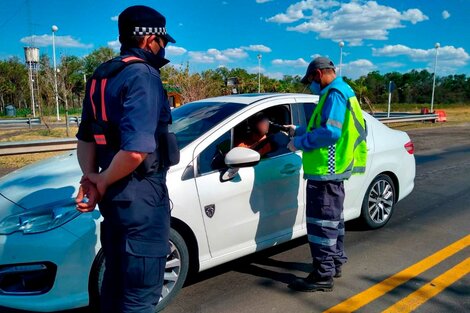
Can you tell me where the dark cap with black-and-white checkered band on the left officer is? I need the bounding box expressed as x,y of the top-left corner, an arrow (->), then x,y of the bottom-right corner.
118,5 -> 176,43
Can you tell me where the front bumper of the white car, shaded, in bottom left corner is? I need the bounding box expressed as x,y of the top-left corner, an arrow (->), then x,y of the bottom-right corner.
0,221 -> 98,312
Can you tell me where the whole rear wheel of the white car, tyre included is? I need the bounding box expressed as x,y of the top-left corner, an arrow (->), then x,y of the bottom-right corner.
361,174 -> 396,229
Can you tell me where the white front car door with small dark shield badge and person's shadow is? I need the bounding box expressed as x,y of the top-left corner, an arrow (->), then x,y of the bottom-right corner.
195,103 -> 304,257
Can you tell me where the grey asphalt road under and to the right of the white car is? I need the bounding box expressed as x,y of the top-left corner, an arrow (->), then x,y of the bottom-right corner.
0,125 -> 470,313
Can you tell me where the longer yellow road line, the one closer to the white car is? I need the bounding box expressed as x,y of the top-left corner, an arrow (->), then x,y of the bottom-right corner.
324,235 -> 470,313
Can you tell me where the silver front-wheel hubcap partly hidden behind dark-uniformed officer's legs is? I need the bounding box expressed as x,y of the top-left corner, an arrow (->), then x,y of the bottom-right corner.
98,241 -> 181,301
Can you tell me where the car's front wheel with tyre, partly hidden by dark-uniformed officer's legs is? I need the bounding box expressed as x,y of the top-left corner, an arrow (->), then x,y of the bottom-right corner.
89,229 -> 189,312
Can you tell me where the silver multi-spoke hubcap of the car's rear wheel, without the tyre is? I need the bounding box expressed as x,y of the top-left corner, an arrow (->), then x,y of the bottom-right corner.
368,180 -> 394,224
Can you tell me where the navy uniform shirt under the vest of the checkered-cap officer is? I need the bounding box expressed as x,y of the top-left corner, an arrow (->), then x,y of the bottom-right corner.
77,48 -> 171,170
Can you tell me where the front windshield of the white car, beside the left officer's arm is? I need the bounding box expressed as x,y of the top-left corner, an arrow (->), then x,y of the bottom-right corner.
170,102 -> 245,149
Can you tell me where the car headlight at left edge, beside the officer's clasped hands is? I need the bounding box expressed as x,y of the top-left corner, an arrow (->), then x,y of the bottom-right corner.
0,202 -> 81,235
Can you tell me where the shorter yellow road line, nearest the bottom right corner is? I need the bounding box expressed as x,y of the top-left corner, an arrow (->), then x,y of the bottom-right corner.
382,258 -> 470,313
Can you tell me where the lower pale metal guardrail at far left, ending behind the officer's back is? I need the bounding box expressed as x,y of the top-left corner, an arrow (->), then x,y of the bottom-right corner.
0,138 -> 77,156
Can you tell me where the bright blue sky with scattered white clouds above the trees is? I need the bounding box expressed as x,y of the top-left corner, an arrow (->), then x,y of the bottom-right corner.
0,0 -> 470,78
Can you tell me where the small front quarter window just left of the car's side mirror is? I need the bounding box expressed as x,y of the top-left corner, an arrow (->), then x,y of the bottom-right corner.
197,131 -> 232,175
